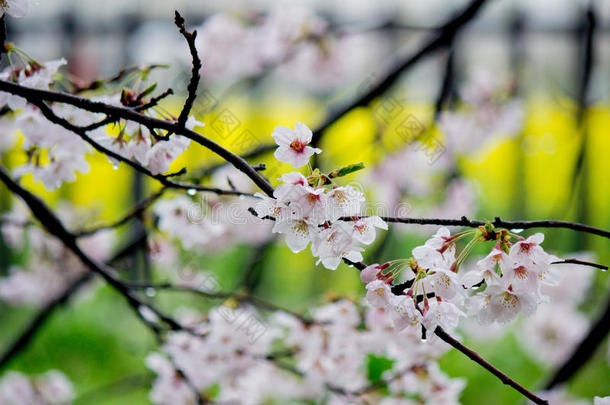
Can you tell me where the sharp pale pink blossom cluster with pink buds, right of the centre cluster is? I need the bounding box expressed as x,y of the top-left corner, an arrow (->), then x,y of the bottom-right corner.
361,225 -> 557,331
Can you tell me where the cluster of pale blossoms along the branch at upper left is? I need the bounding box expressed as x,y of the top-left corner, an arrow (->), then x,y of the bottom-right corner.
0,50 -> 204,190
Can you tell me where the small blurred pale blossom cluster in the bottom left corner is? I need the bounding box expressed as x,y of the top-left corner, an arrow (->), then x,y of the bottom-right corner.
0,370 -> 74,405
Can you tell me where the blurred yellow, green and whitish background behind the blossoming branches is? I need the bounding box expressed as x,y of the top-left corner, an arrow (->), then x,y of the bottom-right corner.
0,0 -> 610,404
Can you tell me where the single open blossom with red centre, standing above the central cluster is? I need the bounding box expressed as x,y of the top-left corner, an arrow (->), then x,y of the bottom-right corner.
271,122 -> 322,168
